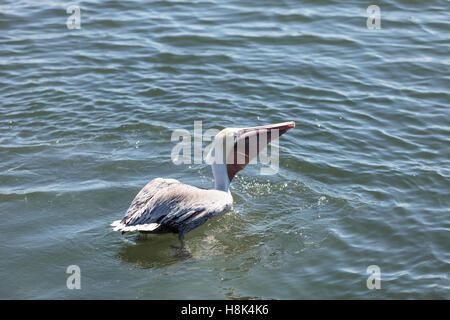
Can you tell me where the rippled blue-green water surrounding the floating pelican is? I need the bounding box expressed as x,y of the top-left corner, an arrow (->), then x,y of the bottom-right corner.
0,0 -> 450,299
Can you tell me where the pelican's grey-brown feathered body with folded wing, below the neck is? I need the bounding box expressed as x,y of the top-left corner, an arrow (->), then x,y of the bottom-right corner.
111,179 -> 232,233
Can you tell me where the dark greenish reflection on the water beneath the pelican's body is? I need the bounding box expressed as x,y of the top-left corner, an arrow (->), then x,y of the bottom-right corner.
117,235 -> 194,269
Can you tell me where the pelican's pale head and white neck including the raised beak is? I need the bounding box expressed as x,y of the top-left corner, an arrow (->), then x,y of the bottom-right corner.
206,121 -> 295,189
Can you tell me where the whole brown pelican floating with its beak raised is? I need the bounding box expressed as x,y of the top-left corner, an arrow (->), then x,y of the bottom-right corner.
111,121 -> 295,245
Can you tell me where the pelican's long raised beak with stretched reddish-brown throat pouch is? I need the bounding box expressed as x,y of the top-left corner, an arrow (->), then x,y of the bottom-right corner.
227,121 -> 295,182
